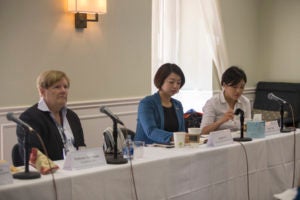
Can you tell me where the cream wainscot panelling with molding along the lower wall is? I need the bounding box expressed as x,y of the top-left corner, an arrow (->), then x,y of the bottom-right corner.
0,88 -> 255,162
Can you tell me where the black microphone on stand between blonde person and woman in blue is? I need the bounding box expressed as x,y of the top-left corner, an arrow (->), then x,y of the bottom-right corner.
100,106 -> 128,164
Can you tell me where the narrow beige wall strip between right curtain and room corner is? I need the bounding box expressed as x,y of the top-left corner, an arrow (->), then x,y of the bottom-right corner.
219,0 -> 261,87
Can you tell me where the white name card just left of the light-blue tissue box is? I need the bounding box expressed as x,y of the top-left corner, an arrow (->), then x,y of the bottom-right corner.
207,129 -> 233,146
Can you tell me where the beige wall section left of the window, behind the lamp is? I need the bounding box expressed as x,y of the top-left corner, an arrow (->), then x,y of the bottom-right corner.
0,0 -> 151,107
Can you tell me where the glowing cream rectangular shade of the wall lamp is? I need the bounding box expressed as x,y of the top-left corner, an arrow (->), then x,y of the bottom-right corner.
68,0 -> 106,14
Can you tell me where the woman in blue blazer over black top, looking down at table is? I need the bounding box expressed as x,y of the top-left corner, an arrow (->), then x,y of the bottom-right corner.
134,63 -> 185,144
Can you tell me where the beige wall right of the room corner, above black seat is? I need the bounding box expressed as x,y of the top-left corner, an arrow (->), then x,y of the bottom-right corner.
259,0 -> 300,82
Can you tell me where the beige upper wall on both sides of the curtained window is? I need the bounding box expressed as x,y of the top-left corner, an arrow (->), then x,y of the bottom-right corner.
0,0 -> 300,107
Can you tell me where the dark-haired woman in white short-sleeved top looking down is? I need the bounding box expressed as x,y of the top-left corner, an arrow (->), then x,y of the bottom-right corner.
201,66 -> 251,134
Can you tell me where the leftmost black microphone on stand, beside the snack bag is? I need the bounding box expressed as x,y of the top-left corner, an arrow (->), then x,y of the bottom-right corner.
6,113 -> 41,179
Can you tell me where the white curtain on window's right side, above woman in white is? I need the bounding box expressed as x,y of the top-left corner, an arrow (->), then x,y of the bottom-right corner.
199,0 -> 229,81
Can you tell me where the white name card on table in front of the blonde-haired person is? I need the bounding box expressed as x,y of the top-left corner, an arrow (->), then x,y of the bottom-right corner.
63,148 -> 106,170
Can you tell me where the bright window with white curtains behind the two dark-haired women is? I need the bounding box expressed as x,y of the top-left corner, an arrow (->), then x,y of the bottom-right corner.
152,0 -> 228,112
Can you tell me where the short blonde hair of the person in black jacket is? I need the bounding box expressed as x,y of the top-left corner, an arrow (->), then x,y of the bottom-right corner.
36,70 -> 70,89
